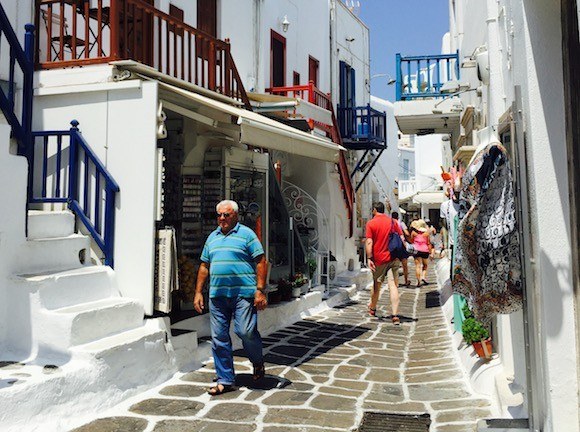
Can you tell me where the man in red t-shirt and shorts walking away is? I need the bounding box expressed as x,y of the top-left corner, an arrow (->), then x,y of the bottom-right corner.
365,202 -> 403,325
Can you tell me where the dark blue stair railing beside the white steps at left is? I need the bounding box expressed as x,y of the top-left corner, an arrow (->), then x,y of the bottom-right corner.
29,120 -> 119,267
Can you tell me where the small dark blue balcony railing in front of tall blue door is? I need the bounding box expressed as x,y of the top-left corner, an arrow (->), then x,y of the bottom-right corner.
338,105 -> 387,150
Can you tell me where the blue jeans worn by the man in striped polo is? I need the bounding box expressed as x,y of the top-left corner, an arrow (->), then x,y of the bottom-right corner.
209,297 -> 264,385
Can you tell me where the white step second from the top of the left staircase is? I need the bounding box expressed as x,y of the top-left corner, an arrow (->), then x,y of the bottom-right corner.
16,234 -> 90,274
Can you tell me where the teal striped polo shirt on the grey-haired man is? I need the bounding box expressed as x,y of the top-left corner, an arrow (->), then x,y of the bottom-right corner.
200,223 -> 264,298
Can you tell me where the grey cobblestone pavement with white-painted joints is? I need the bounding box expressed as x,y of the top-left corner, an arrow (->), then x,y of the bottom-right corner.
75,269 -> 490,432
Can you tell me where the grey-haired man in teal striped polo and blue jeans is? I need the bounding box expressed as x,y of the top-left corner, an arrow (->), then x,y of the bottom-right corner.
193,200 -> 268,396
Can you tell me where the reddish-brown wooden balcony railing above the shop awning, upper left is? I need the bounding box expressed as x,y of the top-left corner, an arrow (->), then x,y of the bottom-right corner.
35,0 -> 250,109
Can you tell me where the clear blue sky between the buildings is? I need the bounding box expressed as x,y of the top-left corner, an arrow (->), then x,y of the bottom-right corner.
358,0 -> 449,102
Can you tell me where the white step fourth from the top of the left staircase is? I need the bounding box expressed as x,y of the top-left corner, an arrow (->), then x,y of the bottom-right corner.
43,297 -> 144,349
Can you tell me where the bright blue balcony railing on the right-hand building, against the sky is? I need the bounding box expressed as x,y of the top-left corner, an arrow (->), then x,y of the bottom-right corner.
396,51 -> 459,101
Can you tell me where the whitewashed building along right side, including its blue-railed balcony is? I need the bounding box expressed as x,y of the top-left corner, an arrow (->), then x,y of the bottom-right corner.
395,0 -> 580,432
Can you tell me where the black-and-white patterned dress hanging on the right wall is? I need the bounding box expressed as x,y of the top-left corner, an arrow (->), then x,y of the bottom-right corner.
452,142 -> 522,323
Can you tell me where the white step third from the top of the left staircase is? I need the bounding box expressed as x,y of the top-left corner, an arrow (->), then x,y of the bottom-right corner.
14,266 -> 119,310
